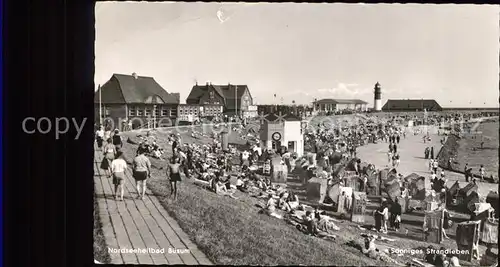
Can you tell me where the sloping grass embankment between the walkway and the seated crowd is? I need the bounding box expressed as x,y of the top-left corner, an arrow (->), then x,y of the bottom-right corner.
118,141 -> 386,266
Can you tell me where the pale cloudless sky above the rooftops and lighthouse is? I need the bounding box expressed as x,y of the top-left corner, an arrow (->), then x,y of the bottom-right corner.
95,2 -> 500,107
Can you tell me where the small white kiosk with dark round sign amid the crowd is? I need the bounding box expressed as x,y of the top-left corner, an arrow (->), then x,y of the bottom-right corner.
260,114 -> 307,157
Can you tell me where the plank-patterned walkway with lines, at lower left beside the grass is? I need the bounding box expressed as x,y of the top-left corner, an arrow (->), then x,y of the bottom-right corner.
94,151 -> 212,265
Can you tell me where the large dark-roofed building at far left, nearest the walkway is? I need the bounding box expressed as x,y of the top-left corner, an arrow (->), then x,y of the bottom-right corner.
94,73 -> 180,130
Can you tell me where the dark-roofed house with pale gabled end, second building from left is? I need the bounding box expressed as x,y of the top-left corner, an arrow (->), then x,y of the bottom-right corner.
186,83 -> 257,117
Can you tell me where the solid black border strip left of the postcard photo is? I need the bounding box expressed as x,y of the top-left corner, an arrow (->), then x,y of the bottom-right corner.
2,0 -> 500,266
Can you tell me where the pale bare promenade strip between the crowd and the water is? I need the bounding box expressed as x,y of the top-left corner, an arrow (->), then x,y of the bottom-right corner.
357,126 -> 498,197
